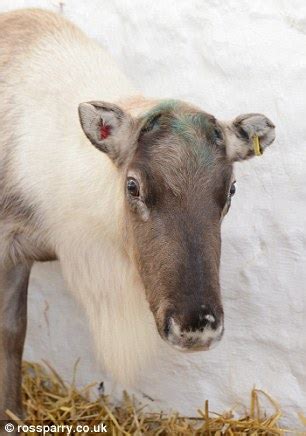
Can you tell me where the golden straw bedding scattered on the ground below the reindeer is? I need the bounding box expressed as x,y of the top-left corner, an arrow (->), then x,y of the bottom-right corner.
8,362 -> 306,436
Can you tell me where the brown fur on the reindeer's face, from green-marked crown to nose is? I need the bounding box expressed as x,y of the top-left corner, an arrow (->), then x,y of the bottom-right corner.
123,102 -> 232,337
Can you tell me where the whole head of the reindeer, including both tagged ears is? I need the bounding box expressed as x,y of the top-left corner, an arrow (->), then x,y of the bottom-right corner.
80,101 -> 274,351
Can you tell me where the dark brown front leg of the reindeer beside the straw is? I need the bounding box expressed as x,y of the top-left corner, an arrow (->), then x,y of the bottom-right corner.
0,265 -> 31,426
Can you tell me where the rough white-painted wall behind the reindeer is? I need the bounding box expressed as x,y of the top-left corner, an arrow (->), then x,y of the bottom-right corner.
0,0 -> 306,430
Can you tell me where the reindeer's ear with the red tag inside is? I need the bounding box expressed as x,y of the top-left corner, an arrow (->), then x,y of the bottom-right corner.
79,101 -> 133,166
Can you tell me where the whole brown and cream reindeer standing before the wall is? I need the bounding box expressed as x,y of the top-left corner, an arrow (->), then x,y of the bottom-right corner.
0,9 -> 275,419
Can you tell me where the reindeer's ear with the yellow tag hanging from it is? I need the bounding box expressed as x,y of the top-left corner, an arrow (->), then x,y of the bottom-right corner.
223,114 -> 275,161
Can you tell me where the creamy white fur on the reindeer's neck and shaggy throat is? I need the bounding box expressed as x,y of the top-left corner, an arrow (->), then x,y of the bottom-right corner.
3,10 -> 160,382
